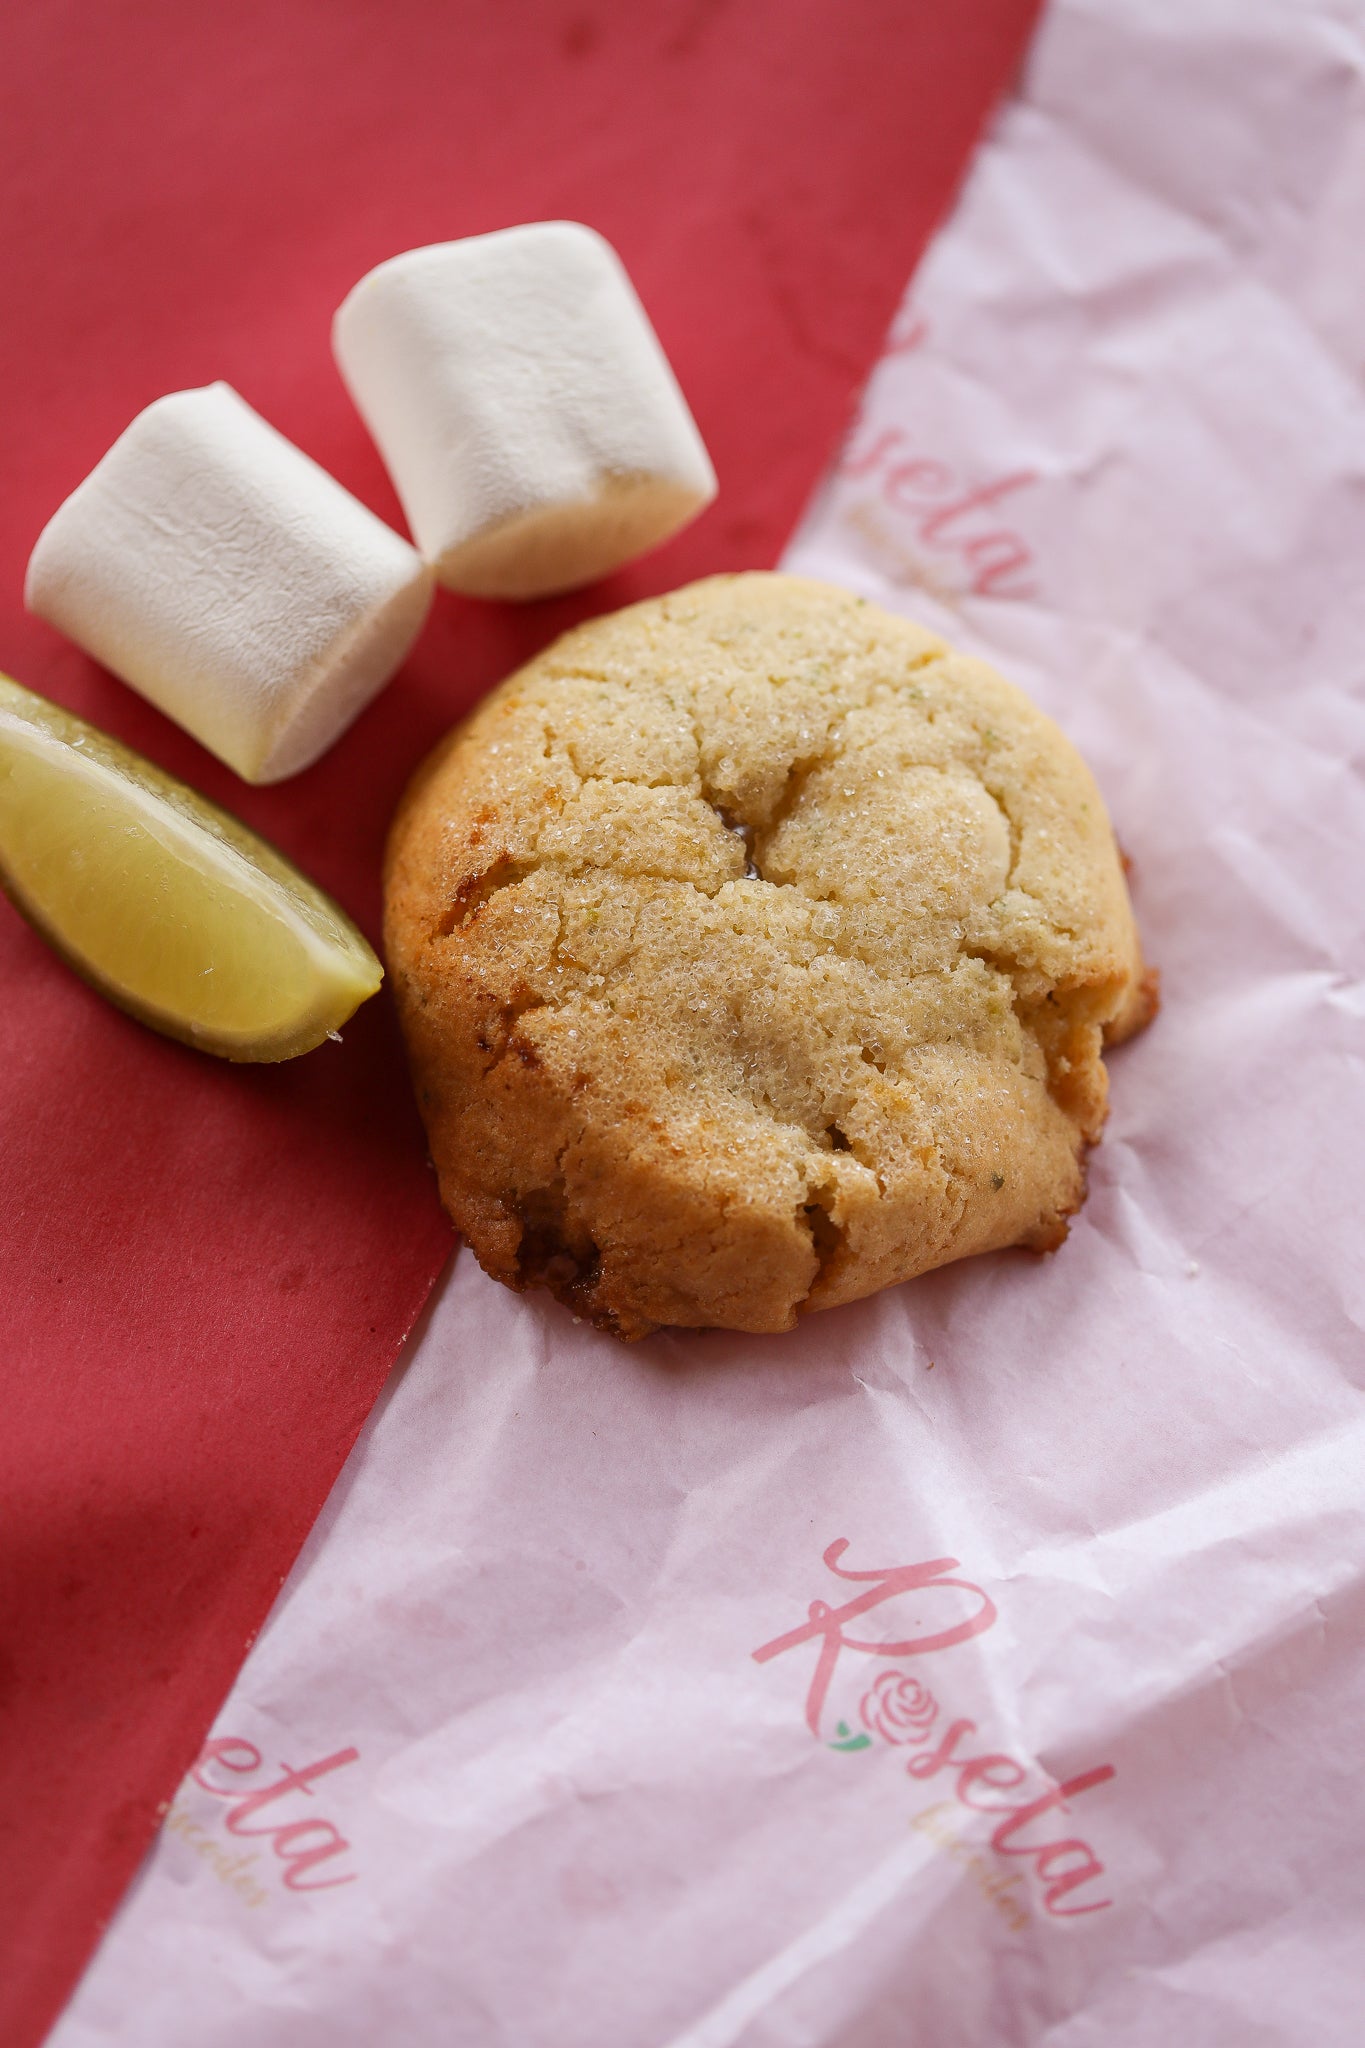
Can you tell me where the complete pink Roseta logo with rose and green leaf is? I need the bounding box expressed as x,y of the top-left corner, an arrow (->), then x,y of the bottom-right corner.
753,1538 -> 1115,1925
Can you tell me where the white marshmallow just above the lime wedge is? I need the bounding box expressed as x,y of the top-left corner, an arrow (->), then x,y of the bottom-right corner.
25,383 -> 432,782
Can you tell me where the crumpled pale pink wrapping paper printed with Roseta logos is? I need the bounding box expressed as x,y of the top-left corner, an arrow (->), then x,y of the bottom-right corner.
55,0 -> 1365,2048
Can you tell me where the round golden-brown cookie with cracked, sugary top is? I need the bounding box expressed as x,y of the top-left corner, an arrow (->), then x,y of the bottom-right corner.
385,575 -> 1152,1337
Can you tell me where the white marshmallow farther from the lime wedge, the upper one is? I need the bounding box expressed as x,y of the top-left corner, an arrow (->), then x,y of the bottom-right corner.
332,221 -> 716,598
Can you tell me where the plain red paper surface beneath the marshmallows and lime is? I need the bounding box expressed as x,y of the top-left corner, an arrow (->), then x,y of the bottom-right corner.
0,0 -> 1036,2048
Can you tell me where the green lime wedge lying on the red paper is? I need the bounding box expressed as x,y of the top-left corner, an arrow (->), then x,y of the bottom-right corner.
0,676 -> 383,1059
